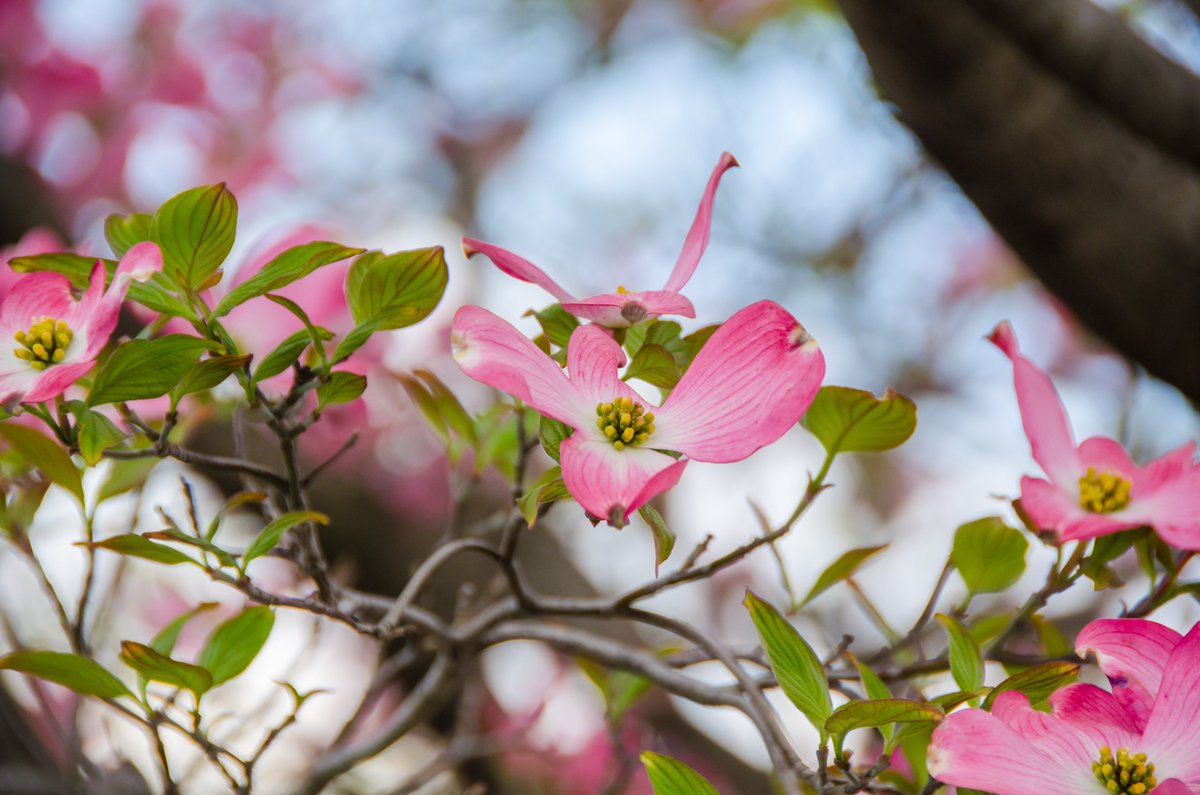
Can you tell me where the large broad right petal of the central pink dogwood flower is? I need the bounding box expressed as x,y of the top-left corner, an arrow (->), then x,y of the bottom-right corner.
649,300 -> 824,464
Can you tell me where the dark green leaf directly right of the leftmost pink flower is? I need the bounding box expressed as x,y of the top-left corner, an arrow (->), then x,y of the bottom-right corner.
88,334 -> 214,406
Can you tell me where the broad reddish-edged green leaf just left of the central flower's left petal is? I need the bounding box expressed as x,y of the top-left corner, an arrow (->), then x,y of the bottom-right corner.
346,246 -> 449,329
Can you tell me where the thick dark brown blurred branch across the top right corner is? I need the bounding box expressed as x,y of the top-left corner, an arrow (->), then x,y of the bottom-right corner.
839,0 -> 1200,401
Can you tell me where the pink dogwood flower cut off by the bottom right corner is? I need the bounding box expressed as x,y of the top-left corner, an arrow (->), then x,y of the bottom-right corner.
929,618 -> 1200,795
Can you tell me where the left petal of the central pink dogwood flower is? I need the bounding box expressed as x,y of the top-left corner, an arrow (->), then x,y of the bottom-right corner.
450,306 -> 595,428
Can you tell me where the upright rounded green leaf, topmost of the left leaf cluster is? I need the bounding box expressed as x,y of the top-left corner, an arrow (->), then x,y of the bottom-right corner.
150,183 -> 238,289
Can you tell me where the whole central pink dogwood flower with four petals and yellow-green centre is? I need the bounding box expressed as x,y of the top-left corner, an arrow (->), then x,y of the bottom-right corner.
452,300 -> 824,527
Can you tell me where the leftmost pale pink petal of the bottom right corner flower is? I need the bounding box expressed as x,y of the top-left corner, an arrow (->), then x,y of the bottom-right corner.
926,694 -> 1096,795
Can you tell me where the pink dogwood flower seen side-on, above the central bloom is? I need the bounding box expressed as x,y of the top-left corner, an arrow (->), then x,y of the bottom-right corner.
462,151 -> 738,329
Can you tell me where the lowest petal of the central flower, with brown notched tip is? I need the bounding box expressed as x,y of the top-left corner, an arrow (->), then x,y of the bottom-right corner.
560,426 -> 688,527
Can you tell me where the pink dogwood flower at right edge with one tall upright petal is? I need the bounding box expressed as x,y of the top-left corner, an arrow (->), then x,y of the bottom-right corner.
988,322 -> 1200,550
